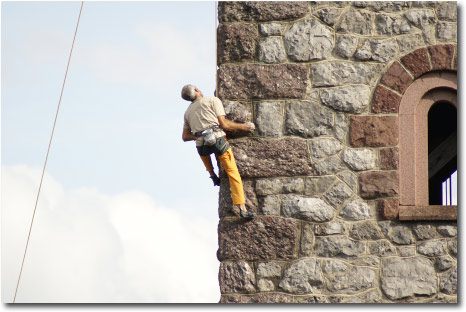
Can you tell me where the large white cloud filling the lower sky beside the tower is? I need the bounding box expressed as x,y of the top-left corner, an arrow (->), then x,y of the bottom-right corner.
2,166 -> 220,302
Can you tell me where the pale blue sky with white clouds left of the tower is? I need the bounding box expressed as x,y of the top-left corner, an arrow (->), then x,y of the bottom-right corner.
1,1 -> 224,303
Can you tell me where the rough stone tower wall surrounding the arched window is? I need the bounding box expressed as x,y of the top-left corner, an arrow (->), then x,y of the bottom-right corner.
217,1 -> 457,303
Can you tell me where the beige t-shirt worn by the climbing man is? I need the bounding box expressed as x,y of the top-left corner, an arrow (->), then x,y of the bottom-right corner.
183,96 -> 225,146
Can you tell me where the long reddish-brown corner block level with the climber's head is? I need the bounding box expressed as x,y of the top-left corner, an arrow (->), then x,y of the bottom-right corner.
218,64 -> 308,100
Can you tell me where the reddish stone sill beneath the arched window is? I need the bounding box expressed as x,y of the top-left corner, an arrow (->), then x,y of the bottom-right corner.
399,205 -> 458,221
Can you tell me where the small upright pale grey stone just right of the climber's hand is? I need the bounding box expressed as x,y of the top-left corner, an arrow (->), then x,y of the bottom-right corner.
255,102 -> 283,137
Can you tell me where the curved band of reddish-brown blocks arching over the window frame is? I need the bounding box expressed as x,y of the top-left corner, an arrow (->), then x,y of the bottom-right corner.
371,44 -> 458,114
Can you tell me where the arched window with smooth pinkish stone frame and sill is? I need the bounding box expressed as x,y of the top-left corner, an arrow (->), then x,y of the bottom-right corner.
399,71 -> 457,220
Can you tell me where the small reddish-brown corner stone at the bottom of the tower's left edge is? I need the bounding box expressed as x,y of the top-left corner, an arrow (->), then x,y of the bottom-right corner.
219,261 -> 256,294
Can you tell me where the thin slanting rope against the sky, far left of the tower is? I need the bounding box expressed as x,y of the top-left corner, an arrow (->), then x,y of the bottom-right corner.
13,1 -> 84,303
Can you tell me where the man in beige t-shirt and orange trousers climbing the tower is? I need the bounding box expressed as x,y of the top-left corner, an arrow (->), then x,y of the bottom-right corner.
181,85 -> 256,219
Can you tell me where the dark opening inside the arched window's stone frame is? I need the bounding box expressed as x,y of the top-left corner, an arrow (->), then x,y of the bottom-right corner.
428,101 -> 457,205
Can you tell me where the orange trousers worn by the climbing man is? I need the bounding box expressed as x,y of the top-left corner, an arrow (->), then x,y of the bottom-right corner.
201,148 -> 245,205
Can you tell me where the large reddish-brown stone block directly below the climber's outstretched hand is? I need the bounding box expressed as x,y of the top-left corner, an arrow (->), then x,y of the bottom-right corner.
230,138 -> 311,178
